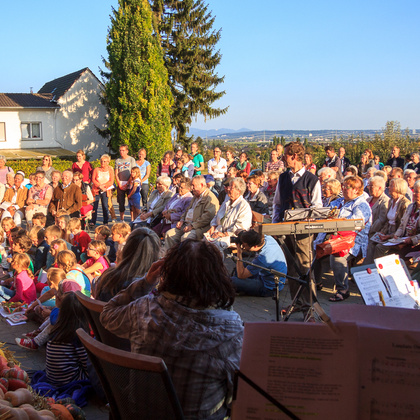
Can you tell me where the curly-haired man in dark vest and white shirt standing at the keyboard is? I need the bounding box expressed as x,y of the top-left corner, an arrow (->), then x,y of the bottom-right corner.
273,142 -> 322,317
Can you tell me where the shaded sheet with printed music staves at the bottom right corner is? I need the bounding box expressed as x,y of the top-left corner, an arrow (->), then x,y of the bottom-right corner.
359,327 -> 420,420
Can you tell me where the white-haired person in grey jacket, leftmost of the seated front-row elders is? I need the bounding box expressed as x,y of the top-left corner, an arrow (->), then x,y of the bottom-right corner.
131,175 -> 173,229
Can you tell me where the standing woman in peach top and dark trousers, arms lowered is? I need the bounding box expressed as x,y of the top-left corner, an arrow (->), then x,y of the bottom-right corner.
91,155 -> 114,226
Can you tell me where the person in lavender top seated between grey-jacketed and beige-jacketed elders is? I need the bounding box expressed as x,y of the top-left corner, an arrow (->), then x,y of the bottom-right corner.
153,178 -> 193,237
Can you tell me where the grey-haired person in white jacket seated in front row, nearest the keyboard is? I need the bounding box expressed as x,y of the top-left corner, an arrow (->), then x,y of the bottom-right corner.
204,178 -> 252,250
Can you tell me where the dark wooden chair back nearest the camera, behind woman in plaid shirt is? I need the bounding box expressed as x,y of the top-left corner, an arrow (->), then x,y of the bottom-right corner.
77,328 -> 184,420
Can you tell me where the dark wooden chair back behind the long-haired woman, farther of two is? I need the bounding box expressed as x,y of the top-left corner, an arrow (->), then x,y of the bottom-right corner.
76,291 -> 131,351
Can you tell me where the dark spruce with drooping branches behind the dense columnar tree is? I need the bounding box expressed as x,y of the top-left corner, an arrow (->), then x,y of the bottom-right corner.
149,0 -> 227,148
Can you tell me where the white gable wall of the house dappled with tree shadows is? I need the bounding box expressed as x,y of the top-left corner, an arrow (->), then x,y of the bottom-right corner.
57,71 -> 108,159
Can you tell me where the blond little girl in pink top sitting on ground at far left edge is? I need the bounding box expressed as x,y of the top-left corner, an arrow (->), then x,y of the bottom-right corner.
0,254 -> 36,304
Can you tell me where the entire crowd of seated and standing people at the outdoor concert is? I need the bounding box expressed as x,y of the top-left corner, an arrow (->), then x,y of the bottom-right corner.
0,142 -> 420,419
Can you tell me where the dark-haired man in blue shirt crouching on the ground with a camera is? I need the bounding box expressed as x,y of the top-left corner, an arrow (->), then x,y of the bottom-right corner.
232,229 -> 287,297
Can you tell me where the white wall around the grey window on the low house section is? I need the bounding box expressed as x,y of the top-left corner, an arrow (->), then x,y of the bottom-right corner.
0,109 -> 60,150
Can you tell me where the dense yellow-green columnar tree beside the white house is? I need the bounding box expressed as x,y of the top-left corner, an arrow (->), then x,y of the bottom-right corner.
102,0 -> 173,169
